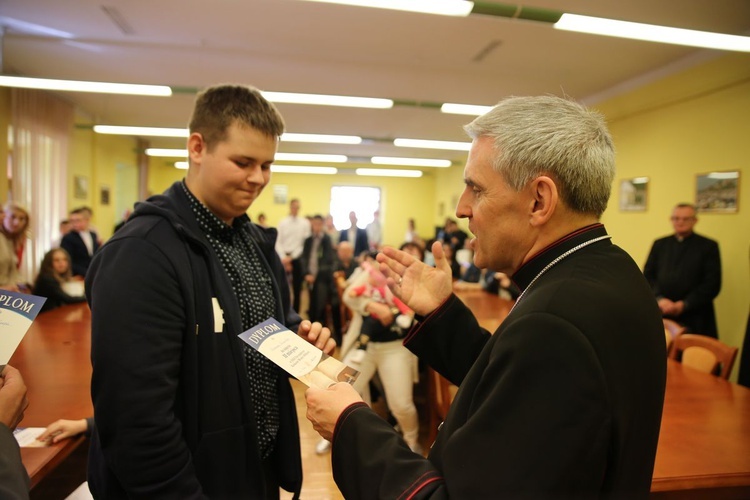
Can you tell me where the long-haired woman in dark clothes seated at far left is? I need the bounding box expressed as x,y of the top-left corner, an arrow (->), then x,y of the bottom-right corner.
33,248 -> 86,312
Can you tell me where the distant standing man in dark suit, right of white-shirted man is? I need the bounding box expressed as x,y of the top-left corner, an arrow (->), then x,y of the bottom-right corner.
301,215 -> 336,324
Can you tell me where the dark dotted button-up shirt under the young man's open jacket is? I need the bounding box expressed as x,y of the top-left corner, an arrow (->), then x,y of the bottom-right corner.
182,182 -> 280,459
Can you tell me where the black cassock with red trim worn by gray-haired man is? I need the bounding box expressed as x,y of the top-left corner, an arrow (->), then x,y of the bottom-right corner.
332,225 -> 666,500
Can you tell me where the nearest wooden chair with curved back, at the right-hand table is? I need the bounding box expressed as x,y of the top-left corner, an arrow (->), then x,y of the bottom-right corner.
669,333 -> 738,379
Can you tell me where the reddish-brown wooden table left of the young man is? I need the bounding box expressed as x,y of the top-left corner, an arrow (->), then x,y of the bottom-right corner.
9,303 -> 94,488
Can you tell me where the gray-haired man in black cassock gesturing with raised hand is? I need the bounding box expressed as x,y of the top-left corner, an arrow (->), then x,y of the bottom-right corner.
306,96 -> 666,499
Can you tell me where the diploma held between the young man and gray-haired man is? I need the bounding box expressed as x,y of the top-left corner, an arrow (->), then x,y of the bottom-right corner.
239,318 -> 359,389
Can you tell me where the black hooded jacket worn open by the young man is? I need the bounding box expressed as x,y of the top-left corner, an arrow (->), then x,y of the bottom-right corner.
86,183 -> 302,499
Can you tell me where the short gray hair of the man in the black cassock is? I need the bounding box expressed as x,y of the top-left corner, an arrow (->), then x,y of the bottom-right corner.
464,96 -> 615,217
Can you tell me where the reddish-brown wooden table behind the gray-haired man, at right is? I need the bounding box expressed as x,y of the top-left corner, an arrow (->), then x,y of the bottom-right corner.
456,289 -> 750,500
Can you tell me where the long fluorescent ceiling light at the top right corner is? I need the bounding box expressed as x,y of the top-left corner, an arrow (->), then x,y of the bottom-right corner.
554,14 -> 750,52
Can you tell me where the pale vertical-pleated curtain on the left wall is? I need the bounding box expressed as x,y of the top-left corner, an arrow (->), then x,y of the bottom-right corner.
9,89 -> 73,282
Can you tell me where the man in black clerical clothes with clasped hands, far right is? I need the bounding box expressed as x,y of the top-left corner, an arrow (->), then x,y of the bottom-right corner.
643,203 -> 721,338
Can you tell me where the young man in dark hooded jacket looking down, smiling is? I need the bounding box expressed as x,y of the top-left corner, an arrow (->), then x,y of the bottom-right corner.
86,85 -> 335,499
